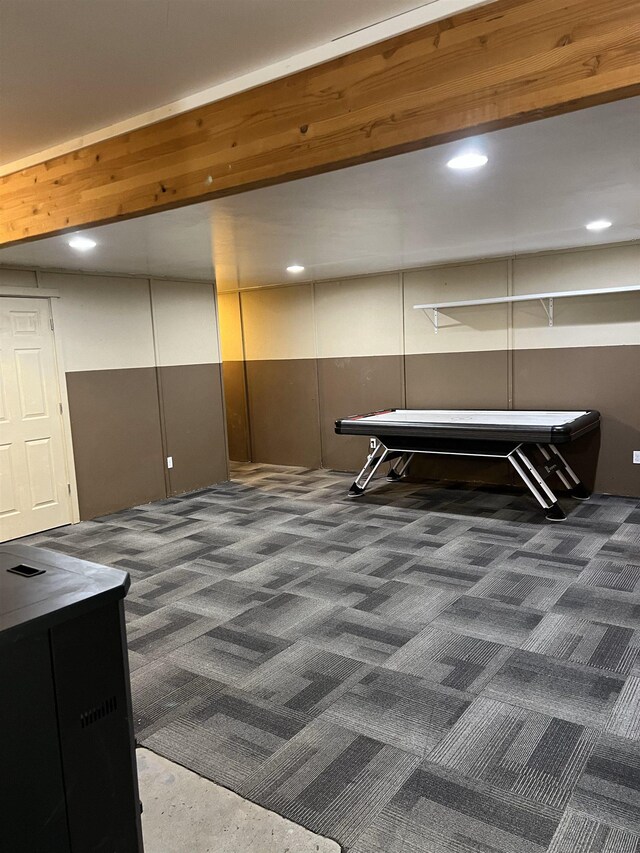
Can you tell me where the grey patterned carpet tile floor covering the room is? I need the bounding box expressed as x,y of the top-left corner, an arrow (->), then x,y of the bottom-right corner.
18,464 -> 640,853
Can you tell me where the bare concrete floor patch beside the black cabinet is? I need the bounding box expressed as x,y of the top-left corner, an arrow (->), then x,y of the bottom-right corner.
136,749 -> 340,853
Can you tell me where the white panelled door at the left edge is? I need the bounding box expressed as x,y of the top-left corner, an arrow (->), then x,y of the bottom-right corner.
0,296 -> 72,542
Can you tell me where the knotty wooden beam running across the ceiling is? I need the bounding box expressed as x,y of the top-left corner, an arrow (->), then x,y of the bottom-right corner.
0,0 -> 640,245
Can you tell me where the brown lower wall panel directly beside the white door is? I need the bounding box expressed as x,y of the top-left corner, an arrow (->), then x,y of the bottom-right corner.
67,367 -> 166,519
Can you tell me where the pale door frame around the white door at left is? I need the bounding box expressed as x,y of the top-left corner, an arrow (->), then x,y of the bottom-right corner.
0,286 -> 80,524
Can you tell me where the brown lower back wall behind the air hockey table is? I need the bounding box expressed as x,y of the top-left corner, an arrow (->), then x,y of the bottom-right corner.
227,346 -> 640,496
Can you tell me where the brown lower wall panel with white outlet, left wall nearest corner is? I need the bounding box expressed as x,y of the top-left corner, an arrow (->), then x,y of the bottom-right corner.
158,364 -> 228,495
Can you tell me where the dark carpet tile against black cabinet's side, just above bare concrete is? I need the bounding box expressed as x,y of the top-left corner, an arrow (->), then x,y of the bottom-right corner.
131,660 -> 226,739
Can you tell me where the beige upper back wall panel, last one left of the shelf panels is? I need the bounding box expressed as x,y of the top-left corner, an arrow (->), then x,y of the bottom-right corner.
315,273 -> 403,358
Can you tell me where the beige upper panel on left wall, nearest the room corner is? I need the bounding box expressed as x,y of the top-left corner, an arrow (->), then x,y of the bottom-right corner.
151,279 -> 220,367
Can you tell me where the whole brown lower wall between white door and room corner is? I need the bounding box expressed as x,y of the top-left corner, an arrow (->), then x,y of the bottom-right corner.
66,364 -> 227,519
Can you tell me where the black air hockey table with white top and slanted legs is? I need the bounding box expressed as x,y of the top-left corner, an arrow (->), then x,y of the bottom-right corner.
335,409 -> 600,521
